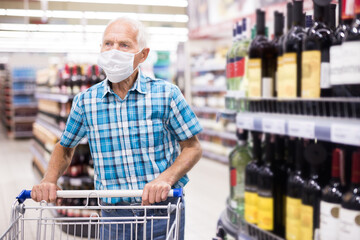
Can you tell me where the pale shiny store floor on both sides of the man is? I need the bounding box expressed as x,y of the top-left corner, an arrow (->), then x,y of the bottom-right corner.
0,127 -> 229,240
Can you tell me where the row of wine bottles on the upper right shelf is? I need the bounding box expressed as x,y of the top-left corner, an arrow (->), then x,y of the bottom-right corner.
227,0 -> 360,99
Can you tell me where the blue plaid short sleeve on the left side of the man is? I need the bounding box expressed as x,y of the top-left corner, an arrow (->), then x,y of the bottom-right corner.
60,93 -> 86,148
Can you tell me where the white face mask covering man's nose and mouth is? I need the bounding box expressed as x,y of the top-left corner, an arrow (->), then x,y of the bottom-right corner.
98,49 -> 142,83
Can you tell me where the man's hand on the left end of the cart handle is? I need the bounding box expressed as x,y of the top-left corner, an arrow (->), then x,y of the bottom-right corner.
31,181 -> 61,203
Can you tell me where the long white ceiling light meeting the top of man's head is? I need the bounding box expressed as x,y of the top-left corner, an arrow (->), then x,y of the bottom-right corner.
0,9 -> 189,23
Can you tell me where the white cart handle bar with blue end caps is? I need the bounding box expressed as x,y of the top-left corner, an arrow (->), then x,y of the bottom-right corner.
16,188 -> 184,203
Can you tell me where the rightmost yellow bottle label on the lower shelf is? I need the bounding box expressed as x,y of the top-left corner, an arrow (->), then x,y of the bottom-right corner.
300,204 -> 314,240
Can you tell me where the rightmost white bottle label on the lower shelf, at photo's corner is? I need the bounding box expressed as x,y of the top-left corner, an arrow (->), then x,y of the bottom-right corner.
338,208 -> 360,240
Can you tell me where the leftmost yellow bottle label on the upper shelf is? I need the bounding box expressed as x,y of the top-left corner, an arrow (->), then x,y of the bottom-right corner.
248,58 -> 261,97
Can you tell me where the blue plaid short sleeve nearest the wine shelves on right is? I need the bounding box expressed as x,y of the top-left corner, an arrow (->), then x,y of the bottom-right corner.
167,85 -> 202,141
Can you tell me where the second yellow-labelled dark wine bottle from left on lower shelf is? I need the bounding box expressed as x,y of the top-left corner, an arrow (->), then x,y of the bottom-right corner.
257,134 -> 281,232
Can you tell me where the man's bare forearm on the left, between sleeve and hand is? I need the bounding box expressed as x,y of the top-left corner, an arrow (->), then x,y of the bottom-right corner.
42,143 -> 74,184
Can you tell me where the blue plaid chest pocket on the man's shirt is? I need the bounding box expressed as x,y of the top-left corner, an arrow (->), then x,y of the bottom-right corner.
129,119 -> 165,149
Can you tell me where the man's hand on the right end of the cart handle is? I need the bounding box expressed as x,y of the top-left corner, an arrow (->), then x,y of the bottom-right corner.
141,179 -> 171,205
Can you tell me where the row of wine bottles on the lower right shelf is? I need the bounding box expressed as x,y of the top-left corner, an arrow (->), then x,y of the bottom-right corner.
230,131 -> 360,240
